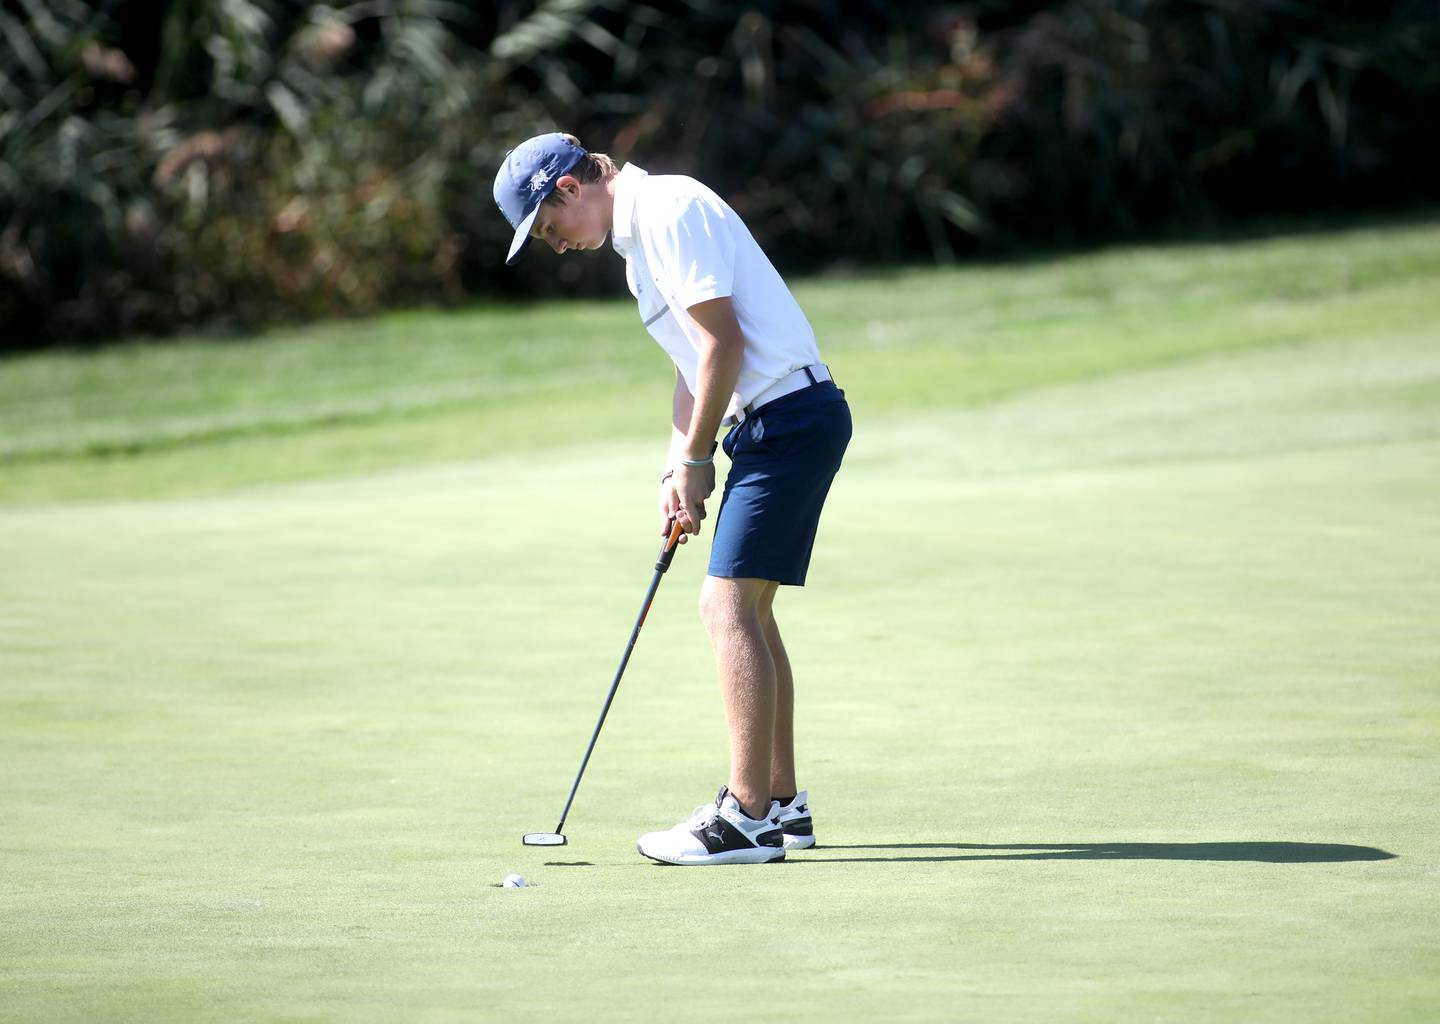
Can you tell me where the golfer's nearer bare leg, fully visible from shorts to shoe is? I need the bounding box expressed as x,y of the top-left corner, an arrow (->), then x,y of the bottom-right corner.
700,576 -> 793,818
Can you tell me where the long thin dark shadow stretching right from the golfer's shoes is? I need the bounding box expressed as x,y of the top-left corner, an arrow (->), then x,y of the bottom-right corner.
788,843 -> 1395,864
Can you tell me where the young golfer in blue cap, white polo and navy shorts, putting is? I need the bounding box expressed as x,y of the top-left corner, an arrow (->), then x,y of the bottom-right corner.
495,133 -> 851,864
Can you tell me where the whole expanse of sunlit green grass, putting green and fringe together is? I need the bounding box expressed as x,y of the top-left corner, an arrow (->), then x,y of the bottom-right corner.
0,216 -> 1440,1023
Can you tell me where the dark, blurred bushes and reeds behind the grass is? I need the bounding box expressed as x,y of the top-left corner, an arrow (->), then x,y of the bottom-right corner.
0,0 -> 1440,349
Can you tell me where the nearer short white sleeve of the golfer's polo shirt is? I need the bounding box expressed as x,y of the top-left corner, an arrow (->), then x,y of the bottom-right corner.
641,185 -> 734,310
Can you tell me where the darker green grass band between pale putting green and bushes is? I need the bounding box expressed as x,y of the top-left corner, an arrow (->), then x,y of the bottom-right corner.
0,213 -> 1440,483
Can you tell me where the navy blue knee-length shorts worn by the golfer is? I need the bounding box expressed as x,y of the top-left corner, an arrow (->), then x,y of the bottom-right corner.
710,380 -> 851,586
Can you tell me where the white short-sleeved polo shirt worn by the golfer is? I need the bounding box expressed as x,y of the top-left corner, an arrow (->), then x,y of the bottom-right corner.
612,164 -> 819,416
